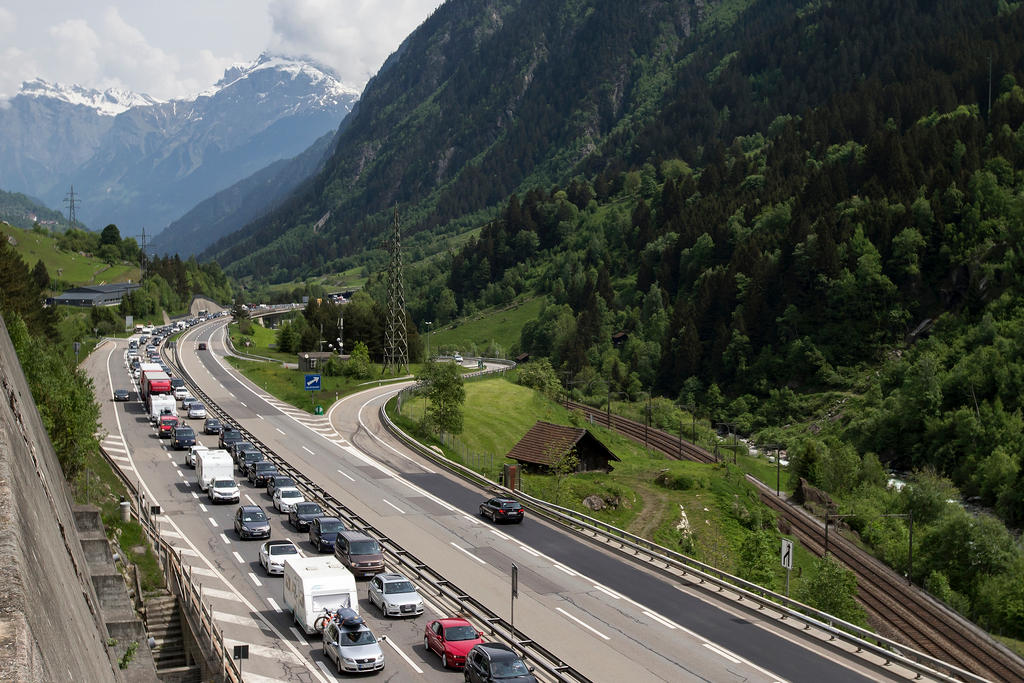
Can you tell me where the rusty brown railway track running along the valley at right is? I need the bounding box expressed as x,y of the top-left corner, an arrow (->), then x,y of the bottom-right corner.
563,400 -> 1024,682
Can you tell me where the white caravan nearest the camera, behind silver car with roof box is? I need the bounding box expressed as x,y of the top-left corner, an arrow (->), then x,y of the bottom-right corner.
282,557 -> 359,634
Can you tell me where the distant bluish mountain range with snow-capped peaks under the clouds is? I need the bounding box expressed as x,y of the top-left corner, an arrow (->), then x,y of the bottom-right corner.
0,53 -> 358,240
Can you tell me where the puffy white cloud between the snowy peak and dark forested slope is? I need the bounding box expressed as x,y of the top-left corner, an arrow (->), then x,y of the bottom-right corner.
268,0 -> 440,87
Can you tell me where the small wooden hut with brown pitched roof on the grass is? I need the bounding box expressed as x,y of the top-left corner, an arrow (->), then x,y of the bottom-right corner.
505,421 -> 620,472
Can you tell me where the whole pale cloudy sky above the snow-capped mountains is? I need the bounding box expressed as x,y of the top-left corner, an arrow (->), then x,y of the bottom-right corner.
0,0 -> 442,99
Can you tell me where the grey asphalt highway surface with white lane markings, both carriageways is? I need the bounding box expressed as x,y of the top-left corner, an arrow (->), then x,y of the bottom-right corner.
86,321 -> 884,681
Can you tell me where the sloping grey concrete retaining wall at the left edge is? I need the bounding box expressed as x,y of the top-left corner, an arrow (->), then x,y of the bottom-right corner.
0,318 -> 124,681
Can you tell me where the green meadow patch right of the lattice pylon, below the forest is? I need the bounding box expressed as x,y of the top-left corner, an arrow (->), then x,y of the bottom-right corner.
421,297 -> 544,356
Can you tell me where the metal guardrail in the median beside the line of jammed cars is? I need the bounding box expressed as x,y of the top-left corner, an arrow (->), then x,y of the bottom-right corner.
165,342 -> 590,683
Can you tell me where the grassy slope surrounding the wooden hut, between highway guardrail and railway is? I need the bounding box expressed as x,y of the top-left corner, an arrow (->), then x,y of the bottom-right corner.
389,378 -> 810,589
